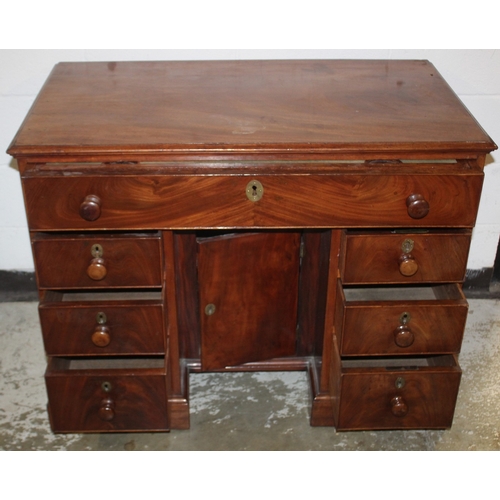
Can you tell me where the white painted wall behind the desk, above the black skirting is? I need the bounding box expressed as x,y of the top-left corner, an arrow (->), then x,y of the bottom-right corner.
0,49 -> 500,271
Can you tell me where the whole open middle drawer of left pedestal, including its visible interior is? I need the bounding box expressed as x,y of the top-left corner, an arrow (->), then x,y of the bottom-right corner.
38,290 -> 165,356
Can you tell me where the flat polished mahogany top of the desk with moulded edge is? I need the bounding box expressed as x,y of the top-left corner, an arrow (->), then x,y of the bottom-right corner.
8,60 -> 496,157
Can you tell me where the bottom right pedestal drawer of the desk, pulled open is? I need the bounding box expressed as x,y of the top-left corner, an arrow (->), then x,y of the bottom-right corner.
337,356 -> 461,430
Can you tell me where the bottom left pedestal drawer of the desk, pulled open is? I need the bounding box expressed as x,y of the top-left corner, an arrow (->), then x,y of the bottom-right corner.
45,358 -> 168,432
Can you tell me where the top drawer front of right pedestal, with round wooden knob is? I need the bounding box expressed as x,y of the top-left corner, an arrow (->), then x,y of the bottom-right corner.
341,231 -> 471,284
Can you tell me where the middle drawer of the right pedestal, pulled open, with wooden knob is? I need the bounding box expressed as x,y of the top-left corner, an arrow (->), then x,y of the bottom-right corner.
337,285 -> 468,356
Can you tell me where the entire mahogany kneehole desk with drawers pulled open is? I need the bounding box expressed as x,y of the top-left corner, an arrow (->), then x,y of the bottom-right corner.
8,60 -> 496,432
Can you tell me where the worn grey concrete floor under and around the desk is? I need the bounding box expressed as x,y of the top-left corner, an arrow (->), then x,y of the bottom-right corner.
0,299 -> 500,450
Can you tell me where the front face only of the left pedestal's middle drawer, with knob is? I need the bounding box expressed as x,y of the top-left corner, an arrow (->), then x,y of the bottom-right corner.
39,302 -> 165,356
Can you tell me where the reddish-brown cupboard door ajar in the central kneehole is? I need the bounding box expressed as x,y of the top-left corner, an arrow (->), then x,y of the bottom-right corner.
198,232 -> 301,370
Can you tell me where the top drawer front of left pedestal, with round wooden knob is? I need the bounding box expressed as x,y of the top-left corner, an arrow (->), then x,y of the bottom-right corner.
33,235 -> 162,289
